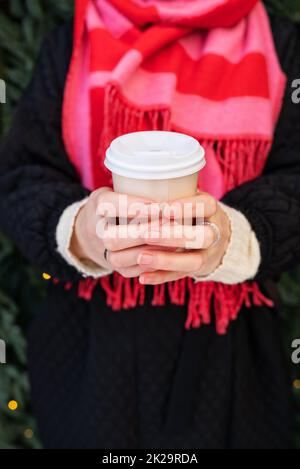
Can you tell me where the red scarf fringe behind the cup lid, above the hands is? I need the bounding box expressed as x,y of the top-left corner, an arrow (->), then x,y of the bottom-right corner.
99,82 -> 272,196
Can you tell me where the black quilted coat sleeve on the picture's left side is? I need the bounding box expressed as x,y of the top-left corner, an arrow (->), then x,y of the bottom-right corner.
0,25 -> 88,280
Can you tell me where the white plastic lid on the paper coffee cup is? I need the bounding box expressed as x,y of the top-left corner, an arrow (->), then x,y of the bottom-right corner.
104,131 -> 206,179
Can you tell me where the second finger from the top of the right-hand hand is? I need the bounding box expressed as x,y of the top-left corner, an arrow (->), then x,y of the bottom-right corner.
143,224 -> 216,249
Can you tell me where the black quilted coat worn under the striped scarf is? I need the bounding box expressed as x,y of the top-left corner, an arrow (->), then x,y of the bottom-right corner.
0,13 -> 300,449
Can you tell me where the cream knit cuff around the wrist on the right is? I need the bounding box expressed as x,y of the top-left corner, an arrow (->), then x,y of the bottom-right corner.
193,204 -> 261,285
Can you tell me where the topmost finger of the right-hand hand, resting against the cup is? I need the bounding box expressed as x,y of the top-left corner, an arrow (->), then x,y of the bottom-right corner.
161,193 -> 218,220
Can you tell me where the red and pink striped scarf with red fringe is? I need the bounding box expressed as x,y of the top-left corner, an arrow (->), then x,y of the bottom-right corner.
63,0 -> 285,334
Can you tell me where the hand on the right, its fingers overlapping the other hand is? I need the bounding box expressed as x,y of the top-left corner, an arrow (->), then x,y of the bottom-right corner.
138,193 -> 231,285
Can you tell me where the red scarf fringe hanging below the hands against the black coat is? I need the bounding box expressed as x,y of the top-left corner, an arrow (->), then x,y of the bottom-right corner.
53,272 -> 274,335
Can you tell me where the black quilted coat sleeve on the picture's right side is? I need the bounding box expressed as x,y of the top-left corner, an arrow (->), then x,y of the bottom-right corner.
223,22 -> 300,280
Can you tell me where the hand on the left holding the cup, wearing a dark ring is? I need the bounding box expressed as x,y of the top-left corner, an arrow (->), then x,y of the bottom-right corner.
70,188 -> 153,278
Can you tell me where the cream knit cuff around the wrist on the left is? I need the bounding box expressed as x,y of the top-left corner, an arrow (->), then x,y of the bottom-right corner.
56,198 -> 112,278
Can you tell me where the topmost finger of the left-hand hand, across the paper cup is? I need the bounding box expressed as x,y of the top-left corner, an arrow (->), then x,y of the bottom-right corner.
97,191 -> 159,218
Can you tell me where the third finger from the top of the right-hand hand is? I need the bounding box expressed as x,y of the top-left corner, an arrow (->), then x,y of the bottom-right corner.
138,247 -> 204,273
